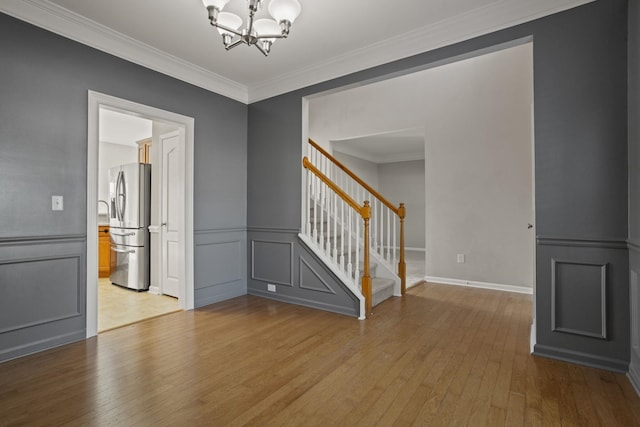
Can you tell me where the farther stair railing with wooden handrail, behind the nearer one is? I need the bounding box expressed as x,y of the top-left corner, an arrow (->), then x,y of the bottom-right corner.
308,139 -> 407,295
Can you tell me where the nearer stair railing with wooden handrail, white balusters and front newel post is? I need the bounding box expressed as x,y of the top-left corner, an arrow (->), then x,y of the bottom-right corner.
302,157 -> 373,317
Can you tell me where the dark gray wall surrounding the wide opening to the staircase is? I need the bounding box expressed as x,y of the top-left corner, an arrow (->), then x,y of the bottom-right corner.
247,0 -> 629,370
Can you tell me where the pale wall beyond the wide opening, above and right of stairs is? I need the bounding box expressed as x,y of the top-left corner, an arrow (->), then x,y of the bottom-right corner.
302,38 -> 536,337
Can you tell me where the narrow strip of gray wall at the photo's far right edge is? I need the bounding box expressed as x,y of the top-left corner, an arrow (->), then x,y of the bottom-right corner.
628,1 -> 640,390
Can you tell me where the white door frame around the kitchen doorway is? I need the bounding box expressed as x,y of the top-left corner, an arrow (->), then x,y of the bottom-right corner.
86,90 -> 195,338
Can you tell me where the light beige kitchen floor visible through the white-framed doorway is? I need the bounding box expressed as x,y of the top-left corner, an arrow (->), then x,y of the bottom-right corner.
98,278 -> 180,332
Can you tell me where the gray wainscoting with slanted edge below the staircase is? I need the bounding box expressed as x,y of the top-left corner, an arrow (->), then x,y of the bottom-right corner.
248,229 -> 360,317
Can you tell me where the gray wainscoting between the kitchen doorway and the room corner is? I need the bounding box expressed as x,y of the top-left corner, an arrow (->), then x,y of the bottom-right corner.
194,230 -> 247,307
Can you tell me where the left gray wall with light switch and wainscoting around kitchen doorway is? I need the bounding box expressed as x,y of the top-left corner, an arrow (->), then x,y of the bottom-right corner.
0,14 -> 247,360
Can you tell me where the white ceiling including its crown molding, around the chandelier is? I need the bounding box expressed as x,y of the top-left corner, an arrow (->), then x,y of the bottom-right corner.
0,0 -> 593,103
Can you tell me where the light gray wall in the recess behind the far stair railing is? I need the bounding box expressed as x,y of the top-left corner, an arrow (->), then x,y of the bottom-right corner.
378,160 -> 425,249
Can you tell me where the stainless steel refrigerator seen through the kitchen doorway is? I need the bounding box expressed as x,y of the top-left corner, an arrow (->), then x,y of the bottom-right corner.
109,163 -> 151,291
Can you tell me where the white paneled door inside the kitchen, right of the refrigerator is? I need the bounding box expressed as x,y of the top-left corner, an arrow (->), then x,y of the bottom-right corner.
160,131 -> 184,298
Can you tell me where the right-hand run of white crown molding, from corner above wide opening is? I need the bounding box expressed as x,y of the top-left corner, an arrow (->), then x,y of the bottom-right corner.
249,0 -> 595,103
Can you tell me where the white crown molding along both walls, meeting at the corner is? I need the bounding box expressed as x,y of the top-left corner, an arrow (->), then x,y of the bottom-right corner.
0,0 -> 595,104
